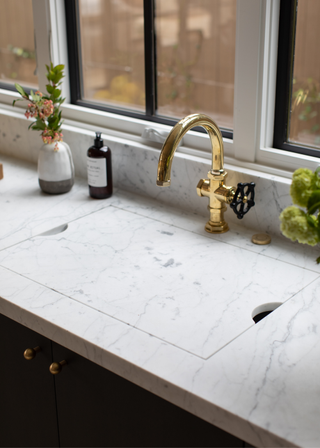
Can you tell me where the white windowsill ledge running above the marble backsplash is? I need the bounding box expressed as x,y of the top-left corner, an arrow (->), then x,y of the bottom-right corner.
0,89 -> 304,179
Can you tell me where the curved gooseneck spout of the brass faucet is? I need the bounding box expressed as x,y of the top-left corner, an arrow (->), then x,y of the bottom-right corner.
157,114 -> 223,187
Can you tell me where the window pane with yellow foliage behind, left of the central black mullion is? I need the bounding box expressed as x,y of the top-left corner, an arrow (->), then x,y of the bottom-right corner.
79,0 -> 145,111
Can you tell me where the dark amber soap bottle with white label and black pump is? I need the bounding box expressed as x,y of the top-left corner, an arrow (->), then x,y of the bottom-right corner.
87,132 -> 113,199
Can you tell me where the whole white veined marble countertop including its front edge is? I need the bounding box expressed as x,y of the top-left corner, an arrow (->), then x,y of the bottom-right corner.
0,158 -> 320,447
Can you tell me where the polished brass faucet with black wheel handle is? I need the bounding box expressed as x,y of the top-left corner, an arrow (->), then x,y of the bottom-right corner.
157,114 -> 255,233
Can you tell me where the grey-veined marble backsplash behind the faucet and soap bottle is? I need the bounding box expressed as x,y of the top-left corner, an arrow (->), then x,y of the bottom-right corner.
0,111 -> 291,236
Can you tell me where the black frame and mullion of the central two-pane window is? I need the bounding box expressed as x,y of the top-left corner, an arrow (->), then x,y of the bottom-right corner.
64,0 -> 233,140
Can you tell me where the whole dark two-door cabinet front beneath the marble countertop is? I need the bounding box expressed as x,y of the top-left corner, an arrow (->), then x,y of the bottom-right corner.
0,315 -> 243,447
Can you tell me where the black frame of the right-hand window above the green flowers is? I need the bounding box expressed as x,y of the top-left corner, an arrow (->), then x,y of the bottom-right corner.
273,0 -> 320,158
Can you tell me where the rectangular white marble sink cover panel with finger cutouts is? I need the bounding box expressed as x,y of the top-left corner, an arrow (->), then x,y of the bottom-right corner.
0,205 -> 318,359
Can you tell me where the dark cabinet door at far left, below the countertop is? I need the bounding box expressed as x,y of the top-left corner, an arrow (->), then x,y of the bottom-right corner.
0,314 -> 59,447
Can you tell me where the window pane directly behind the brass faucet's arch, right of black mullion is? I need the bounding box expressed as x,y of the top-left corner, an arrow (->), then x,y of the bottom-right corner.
156,0 -> 236,129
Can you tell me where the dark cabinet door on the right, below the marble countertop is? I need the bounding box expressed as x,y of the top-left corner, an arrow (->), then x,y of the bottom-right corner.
53,343 -> 243,447
